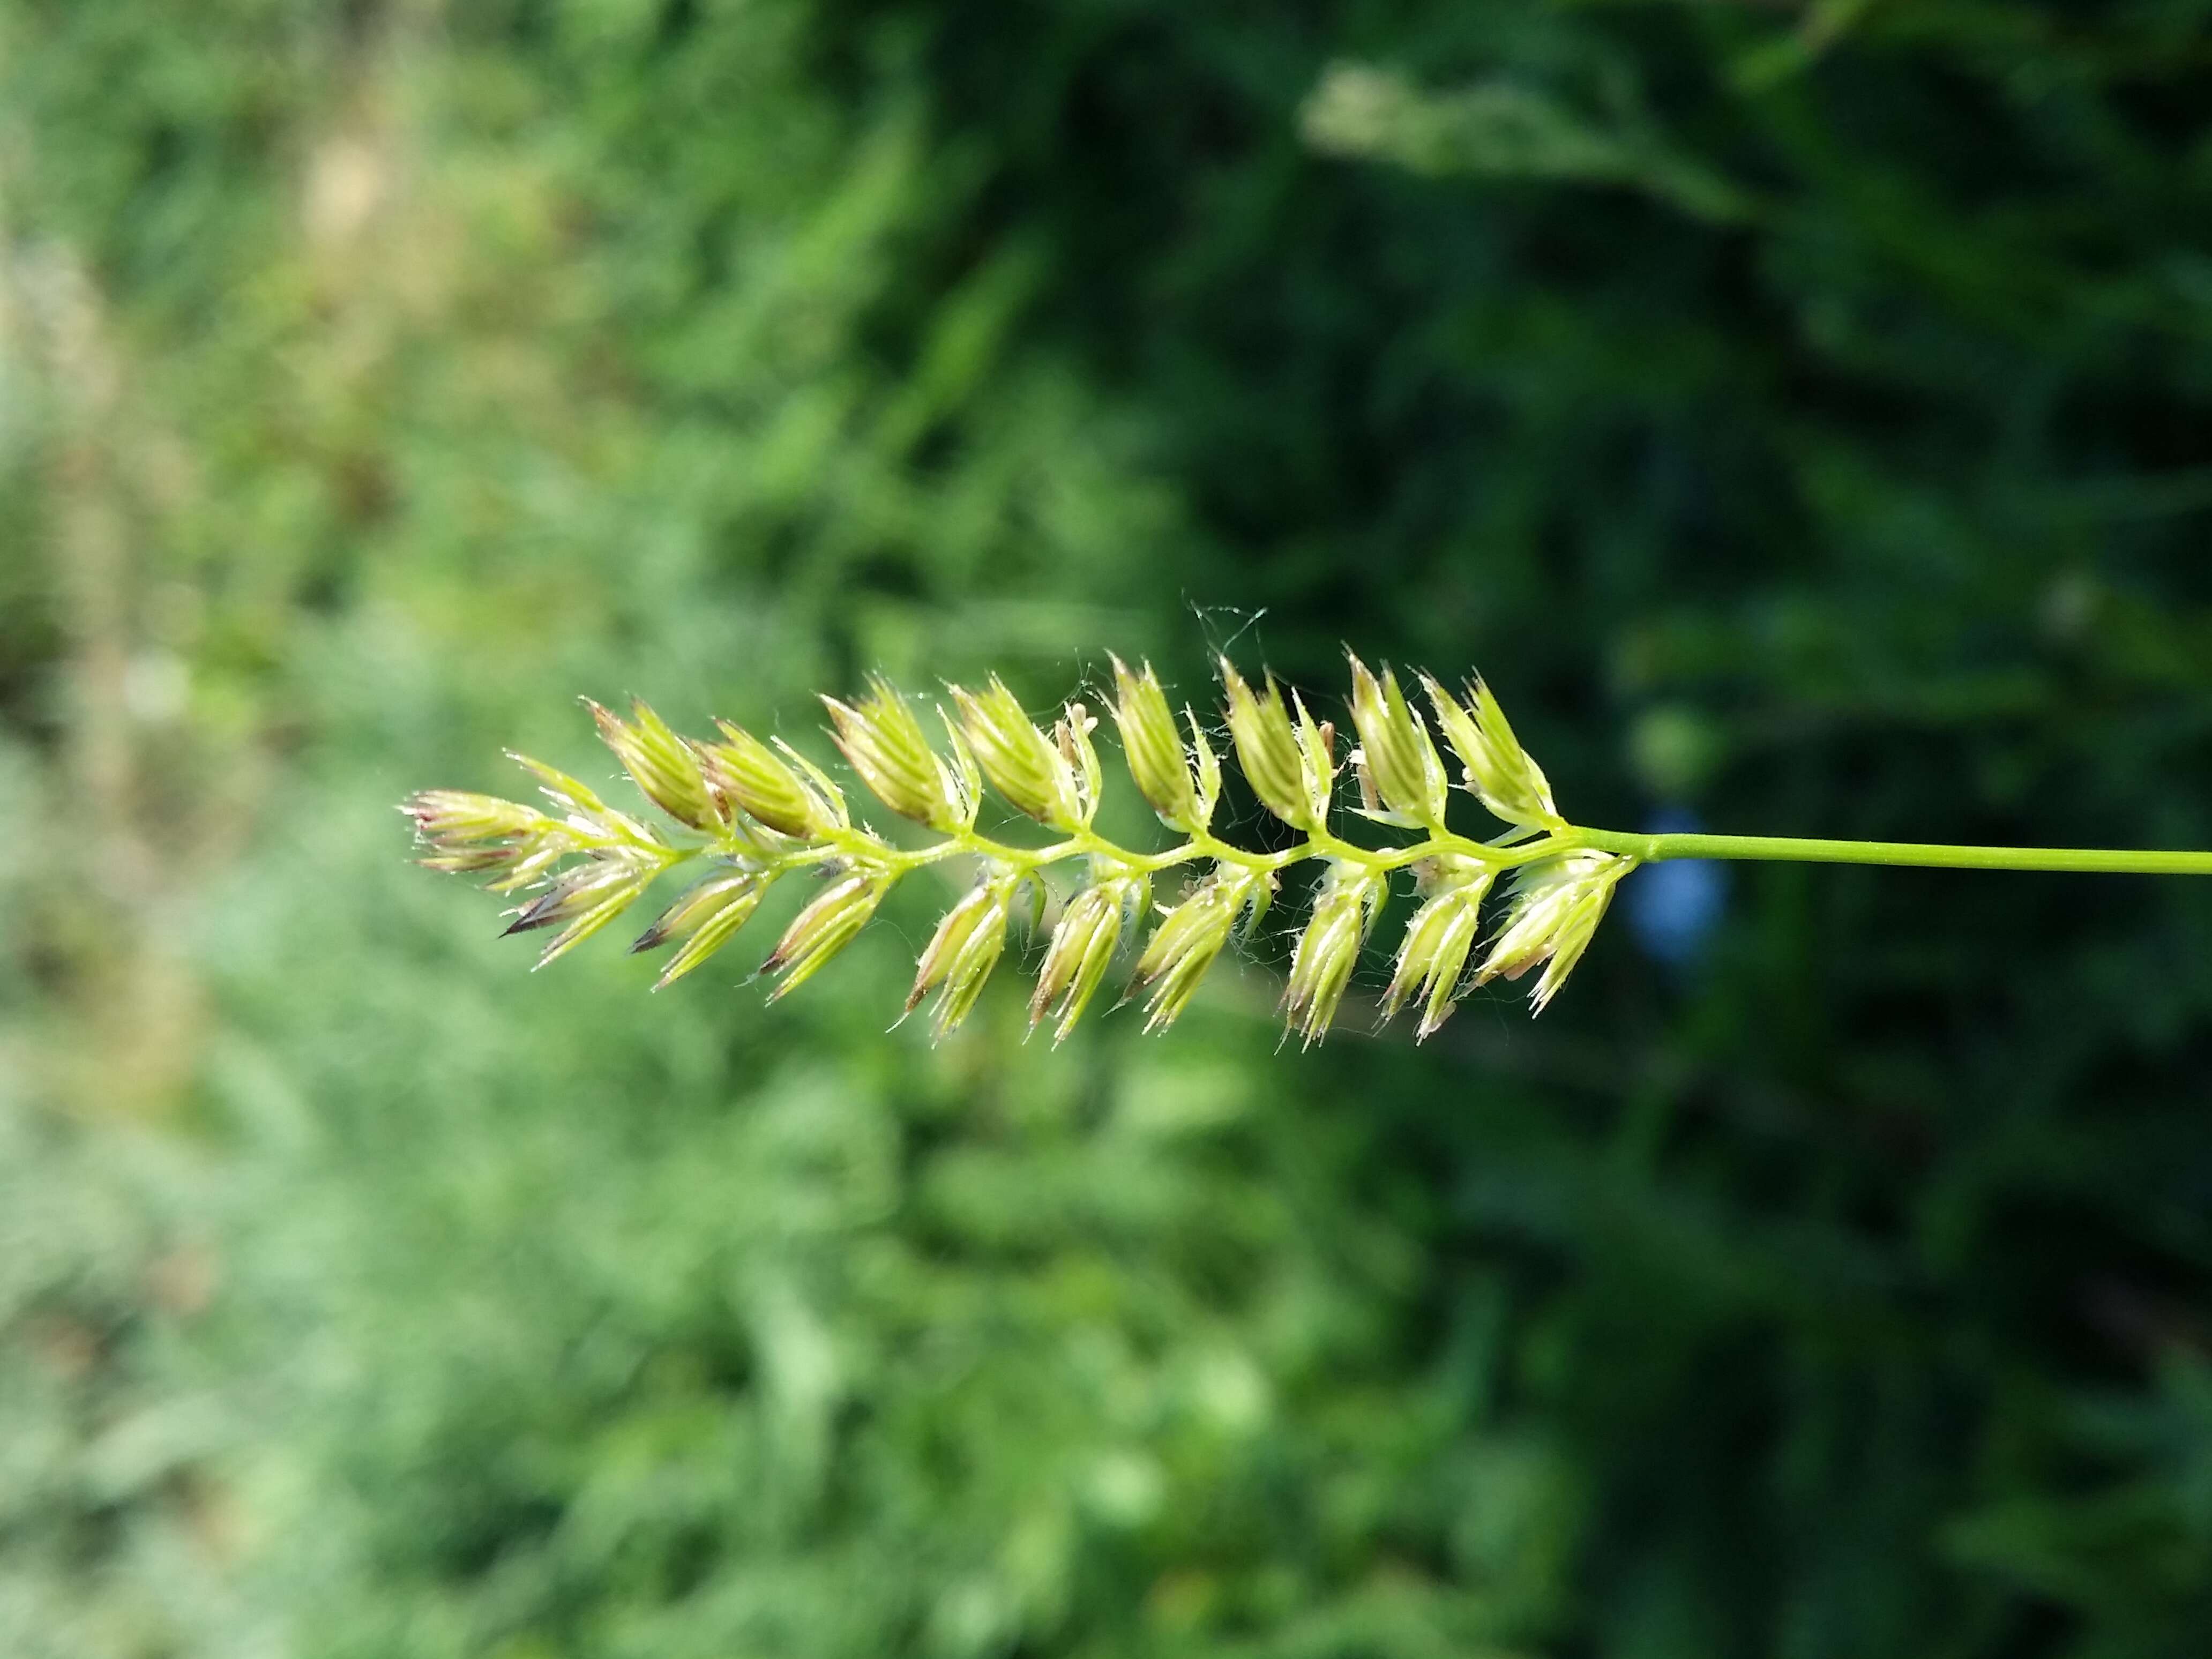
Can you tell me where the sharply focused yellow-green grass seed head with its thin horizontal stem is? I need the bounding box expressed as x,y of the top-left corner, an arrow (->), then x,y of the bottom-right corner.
400,657 -> 2212,1047
